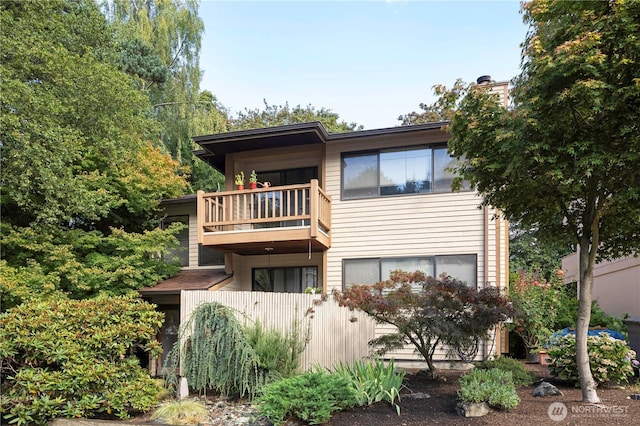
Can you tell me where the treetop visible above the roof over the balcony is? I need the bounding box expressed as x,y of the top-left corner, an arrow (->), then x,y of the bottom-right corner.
229,100 -> 363,133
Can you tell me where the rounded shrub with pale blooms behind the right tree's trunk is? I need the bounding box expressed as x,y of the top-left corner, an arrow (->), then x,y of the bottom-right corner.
548,333 -> 636,384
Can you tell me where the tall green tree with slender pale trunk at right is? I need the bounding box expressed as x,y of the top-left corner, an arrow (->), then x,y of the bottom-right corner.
449,1 -> 640,403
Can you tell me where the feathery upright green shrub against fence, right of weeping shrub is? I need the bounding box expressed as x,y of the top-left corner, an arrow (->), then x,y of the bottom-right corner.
244,320 -> 310,378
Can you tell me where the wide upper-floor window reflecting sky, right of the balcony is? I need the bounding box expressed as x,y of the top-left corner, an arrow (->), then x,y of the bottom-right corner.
342,146 -> 468,199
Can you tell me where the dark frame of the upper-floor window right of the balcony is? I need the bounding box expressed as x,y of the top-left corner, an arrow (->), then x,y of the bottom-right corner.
340,142 -> 471,201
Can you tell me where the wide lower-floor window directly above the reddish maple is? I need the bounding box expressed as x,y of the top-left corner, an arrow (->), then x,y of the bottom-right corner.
342,254 -> 477,288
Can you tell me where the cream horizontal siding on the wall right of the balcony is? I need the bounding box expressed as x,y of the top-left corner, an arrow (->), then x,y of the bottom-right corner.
326,132 -> 508,361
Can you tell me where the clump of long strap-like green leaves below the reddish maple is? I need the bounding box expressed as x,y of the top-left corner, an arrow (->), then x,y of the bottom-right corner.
335,359 -> 405,414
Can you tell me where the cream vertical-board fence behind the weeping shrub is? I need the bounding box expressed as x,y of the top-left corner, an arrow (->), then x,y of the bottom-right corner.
181,291 -> 374,370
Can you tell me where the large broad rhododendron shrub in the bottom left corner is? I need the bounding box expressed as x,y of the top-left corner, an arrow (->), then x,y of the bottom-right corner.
0,297 -> 162,425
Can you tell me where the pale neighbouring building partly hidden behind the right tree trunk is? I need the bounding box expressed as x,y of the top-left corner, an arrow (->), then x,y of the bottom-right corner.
562,253 -> 640,318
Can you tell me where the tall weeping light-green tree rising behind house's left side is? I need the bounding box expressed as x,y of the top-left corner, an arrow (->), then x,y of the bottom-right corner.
101,0 -> 227,191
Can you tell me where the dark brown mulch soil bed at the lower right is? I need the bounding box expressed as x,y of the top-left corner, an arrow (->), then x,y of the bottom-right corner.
328,364 -> 640,426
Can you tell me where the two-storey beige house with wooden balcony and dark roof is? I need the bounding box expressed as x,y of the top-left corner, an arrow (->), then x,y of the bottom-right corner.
142,79 -> 509,370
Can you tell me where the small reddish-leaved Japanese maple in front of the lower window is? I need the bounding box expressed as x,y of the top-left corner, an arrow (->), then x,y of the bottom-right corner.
333,271 -> 513,377
